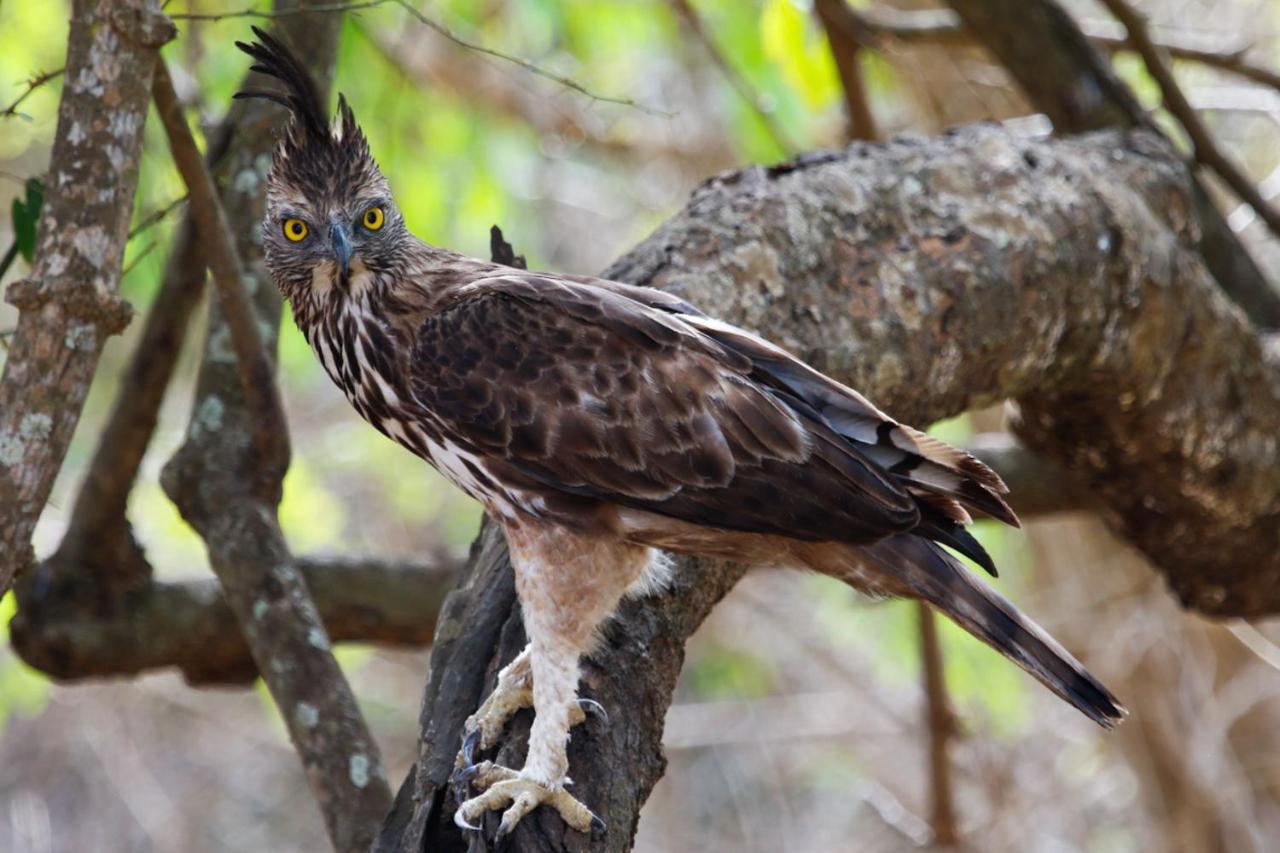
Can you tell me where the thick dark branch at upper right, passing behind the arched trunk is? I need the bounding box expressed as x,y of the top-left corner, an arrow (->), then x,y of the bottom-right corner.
947,0 -> 1280,328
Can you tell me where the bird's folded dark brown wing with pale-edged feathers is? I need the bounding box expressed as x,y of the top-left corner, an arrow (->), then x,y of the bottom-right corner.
412,275 -> 920,542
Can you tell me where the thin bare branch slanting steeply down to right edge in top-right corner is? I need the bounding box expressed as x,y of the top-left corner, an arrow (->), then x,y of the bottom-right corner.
1102,0 -> 1280,237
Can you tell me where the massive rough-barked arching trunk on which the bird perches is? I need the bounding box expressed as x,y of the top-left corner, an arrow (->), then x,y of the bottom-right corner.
376,127 -> 1280,850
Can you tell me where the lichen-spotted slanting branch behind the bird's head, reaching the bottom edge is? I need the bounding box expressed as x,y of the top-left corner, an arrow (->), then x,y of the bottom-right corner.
154,9 -> 390,852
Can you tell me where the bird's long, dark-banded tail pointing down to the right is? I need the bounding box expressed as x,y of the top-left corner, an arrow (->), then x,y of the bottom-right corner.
859,534 -> 1129,729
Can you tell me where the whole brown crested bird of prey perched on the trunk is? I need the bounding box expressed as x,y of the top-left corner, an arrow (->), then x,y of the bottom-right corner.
237,28 -> 1125,834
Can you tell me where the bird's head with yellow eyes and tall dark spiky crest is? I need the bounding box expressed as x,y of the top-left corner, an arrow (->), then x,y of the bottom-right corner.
236,27 -> 404,302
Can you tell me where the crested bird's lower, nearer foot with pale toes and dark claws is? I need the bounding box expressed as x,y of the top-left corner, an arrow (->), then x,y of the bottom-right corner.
453,761 -> 604,838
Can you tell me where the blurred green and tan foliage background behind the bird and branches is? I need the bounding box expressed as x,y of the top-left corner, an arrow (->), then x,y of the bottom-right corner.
0,0 -> 1280,853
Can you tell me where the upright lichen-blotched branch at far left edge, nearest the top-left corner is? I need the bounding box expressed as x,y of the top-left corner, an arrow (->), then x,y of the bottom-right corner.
0,0 -> 173,594
